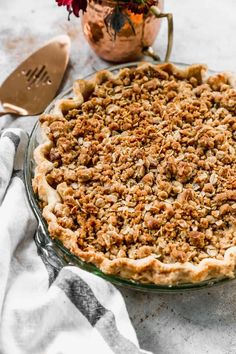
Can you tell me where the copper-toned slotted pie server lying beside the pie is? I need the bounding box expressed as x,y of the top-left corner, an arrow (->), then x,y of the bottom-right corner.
0,35 -> 70,116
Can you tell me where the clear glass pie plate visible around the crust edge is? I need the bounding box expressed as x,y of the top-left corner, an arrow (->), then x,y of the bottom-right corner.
24,62 -> 236,293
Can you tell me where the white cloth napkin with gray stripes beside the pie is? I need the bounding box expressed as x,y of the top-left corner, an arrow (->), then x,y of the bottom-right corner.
0,129 -> 151,354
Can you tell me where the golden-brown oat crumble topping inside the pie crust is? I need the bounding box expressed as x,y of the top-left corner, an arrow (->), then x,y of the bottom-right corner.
42,67 -> 236,264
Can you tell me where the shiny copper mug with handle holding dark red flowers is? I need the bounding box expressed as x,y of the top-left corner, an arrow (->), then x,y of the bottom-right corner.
82,0 -> 173,62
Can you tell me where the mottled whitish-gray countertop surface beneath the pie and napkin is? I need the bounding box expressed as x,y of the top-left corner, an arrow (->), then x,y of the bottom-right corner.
0,0 -> 236,354
